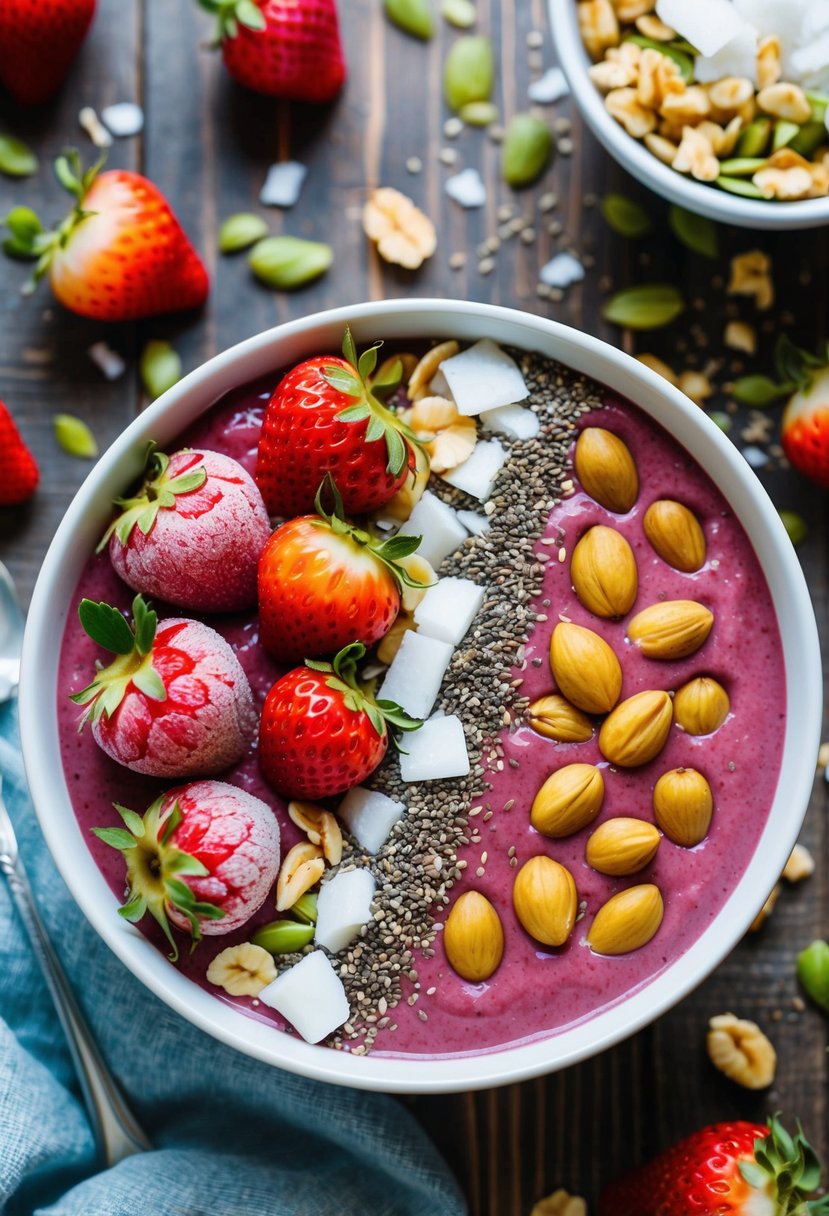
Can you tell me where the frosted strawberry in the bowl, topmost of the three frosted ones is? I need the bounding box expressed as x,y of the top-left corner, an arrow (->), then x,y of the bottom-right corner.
98,449 -> 271,612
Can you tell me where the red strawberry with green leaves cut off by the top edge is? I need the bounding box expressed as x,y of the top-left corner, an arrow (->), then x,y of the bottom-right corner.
199,0 -> 345,102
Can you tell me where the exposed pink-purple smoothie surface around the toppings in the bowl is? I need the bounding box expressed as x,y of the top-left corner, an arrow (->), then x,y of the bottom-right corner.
57,383 -> 785,1058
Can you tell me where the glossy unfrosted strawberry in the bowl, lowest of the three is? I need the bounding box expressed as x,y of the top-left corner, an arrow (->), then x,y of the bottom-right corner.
259,642 -> 421,798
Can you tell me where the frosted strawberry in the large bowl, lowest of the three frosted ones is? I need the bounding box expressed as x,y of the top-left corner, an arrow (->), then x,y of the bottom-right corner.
92,781 -> 280,959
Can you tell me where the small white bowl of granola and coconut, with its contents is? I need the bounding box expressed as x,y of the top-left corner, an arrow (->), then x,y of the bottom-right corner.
551,0 -> 829,230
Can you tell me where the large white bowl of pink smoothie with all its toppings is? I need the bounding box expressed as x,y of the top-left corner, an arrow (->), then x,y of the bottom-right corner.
21,300 -> 820,1092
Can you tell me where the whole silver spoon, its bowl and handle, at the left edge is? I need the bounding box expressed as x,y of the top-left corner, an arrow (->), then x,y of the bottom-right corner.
0,562 -> 152,1166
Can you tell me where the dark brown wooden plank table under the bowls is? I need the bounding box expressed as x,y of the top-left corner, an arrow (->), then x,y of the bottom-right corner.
0,0 -> 829,1216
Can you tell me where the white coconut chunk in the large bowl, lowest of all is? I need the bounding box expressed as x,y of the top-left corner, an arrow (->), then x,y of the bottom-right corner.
259,950 -> 349,1043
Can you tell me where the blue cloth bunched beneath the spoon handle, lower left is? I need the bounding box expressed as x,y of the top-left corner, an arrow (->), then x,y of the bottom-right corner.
0,705 -> 466,1216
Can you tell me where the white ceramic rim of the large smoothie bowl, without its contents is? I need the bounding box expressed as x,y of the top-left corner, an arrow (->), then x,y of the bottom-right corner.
21,300 -> 822,1093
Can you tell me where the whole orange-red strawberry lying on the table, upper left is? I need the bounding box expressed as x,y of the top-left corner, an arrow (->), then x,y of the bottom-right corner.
4,152 -> 209,321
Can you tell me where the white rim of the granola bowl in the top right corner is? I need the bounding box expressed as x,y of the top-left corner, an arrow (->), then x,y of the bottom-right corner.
549,0 -> 829,232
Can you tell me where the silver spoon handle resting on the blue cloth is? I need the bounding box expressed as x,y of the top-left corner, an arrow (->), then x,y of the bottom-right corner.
0,836 -> 152,1166
